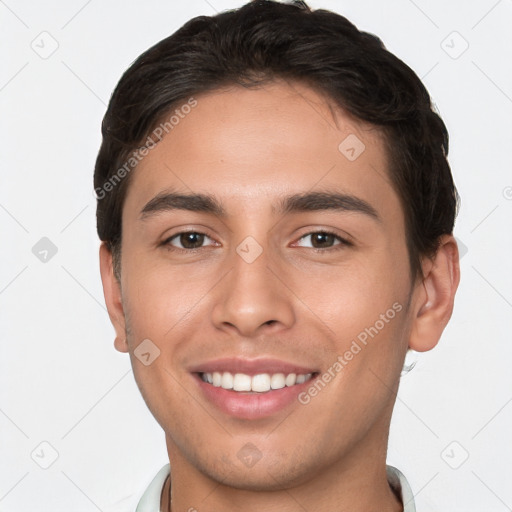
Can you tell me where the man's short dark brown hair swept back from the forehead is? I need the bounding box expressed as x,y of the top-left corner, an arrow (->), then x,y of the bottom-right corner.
94,0 -> 458,277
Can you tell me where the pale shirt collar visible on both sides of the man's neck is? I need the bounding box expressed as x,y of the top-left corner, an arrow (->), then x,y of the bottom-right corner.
135,464 -> 416,512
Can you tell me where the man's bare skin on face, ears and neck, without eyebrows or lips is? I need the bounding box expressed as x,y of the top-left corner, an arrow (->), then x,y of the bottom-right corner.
100,82 -> 459,512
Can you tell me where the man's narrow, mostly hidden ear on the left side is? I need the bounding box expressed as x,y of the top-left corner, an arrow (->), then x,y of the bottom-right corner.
100,242 -> 128,352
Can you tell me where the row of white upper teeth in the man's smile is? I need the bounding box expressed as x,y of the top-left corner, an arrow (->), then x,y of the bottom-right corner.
201,372 -> 313,393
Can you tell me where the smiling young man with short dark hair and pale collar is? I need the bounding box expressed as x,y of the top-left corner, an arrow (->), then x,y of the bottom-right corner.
95,0 -> 459,512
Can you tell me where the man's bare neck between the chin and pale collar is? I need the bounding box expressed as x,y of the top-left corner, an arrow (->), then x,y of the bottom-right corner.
161,420 -> 403,512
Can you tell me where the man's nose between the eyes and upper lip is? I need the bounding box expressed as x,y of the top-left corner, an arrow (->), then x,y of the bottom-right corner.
212,243 -> 295,337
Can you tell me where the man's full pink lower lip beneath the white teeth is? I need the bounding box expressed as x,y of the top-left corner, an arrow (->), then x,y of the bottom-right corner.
194,374 -> 315,420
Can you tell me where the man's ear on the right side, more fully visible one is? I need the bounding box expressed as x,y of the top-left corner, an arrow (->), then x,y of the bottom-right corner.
409,235 -> 460,352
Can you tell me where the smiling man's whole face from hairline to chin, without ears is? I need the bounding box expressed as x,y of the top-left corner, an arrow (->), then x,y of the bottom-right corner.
104,83 -> 416,490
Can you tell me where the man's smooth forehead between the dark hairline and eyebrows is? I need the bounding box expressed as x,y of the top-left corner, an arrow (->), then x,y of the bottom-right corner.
125,82 -> 399,222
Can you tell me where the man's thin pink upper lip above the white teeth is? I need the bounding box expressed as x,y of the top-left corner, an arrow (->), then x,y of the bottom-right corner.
189,357 -> 317,376
